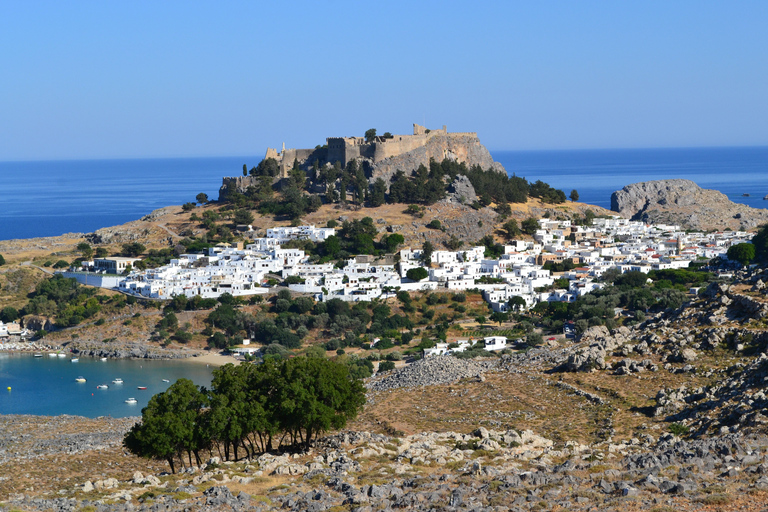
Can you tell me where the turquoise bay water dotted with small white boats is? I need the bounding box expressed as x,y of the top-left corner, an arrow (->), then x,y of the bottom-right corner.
0,353 -> 214,418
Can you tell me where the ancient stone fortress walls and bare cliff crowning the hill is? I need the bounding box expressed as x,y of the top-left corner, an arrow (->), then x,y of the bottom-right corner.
222,123 -> 506,197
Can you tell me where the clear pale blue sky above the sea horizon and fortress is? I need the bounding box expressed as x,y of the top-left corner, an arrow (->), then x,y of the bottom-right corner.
0,0 -> 768,160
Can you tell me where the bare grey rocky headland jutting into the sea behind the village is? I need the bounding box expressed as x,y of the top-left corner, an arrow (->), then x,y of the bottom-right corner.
611,179 -> 768,230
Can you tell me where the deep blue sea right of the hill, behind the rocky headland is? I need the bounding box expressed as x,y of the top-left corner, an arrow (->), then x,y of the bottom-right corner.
492,147 -> 768,208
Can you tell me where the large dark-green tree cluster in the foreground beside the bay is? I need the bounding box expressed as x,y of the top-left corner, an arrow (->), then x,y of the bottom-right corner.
123,357 -> 365,473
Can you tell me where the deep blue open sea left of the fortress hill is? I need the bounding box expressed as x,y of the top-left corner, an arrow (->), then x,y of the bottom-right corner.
0,156 -> 261,240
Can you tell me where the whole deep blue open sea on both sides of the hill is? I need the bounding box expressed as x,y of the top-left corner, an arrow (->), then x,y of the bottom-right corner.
0,147 -> 768,240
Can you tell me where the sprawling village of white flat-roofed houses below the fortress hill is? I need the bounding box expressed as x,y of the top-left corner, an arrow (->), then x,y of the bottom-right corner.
64,216 -> 751,320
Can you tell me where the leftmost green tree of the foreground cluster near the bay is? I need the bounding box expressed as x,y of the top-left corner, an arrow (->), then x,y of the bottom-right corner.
123,379 -> 206,473
